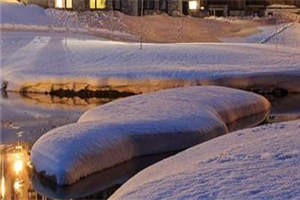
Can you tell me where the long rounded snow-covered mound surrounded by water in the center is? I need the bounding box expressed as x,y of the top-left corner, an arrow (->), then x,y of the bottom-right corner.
31,86 -> 270,185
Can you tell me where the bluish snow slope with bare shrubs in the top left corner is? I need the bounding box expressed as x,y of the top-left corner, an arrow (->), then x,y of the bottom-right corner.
0,1 -> 135,40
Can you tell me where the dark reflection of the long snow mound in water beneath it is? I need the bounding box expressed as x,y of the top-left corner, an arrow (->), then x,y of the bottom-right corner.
32,152 -> 175,199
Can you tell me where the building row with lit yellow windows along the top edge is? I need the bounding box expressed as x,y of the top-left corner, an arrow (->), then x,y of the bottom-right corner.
20,0 -> 300,16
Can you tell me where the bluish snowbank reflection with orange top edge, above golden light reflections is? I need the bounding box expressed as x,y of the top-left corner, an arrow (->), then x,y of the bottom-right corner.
0,93 -> 112,145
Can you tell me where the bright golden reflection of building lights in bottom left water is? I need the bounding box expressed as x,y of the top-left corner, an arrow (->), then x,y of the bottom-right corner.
0,145 -> 47,200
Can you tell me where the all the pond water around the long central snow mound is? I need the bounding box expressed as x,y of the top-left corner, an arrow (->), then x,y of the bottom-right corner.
0,93 -> 300,200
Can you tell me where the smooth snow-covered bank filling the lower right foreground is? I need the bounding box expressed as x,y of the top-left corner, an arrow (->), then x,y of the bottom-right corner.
110,121 -> 300,200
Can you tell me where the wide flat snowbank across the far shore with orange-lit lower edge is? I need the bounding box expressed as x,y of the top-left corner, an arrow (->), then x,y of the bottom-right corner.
1,31 -> 300,93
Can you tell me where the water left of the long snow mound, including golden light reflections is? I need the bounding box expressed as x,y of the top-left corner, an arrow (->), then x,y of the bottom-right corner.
0,92 -> 120,200
